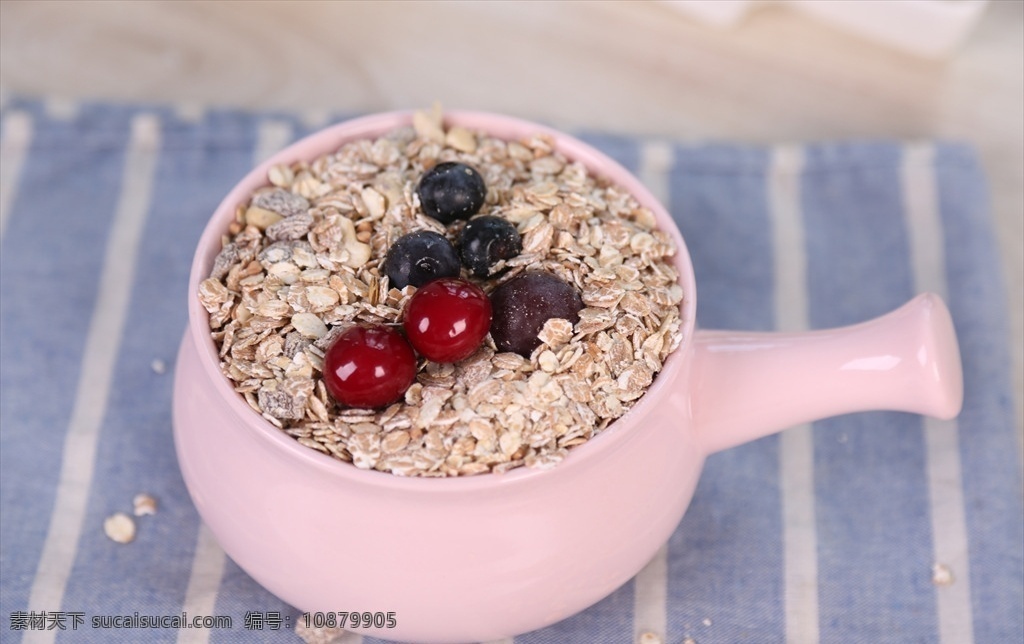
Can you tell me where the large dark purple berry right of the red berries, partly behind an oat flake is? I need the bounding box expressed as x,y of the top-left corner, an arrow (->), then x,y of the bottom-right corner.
490,270 -> 583,357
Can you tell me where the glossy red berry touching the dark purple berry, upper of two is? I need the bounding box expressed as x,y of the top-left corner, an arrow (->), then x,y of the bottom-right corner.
403,277 -> 490,362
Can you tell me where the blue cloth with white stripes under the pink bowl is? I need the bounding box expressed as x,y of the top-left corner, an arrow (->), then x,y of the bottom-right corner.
0,98 -> 1024,644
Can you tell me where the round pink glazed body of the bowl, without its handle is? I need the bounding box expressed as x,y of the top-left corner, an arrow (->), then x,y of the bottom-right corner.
174,113 -> 703,642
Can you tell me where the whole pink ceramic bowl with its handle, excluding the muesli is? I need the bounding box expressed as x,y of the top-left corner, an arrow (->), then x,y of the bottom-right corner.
174,113 -> 962,643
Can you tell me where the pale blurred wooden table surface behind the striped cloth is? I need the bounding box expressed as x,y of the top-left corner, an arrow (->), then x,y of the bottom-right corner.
0,0 -> 1024,454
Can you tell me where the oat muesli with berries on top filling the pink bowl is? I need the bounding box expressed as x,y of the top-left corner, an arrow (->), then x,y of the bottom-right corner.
199,109 -> 684,476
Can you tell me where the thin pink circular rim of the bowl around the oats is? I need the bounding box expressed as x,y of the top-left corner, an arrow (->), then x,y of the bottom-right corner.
182,110 -> 696,493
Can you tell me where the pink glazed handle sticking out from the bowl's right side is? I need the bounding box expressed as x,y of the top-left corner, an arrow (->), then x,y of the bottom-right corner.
690,293 -> 964,454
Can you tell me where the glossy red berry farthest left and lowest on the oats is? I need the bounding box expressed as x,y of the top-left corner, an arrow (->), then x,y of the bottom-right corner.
324,326 -> 416,407
